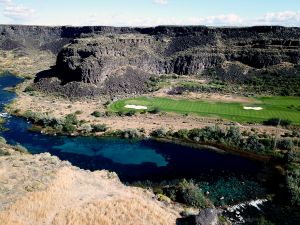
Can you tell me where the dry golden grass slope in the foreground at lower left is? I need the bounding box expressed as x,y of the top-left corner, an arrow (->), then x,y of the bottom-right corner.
0,147 -> 180,225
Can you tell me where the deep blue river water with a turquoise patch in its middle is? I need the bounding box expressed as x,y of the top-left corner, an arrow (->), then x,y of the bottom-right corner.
0,74 -> 261,181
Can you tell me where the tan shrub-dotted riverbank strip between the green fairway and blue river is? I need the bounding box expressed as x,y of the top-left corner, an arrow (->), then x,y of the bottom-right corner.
7,87 -> 297,165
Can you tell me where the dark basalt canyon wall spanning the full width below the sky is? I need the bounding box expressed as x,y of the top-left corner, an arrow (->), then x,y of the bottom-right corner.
0,26 -> 300,95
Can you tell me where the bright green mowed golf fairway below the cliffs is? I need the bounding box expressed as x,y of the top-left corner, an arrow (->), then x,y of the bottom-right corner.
110,97 -> 300,124
